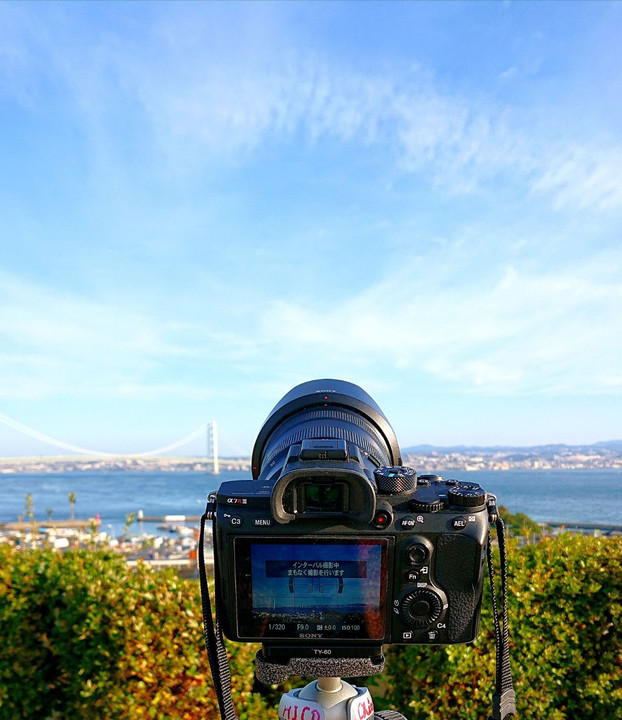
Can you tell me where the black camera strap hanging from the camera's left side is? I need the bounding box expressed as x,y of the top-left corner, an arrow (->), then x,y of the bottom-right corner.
198,499 -> 238,720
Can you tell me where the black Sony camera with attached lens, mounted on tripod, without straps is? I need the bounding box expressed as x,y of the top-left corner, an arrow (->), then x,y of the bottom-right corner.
213,380 -> 489,674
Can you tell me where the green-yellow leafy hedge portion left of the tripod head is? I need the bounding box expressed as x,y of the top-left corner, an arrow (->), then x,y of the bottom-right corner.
0,546 -> 268,720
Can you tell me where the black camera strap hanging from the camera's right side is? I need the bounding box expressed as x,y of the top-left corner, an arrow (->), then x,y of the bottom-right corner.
487,495 -> 516,720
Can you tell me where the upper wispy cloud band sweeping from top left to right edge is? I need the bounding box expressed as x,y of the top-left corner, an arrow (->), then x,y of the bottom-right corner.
5,6 -> 622,211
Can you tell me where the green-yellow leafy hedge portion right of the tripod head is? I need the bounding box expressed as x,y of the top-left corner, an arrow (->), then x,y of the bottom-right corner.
376,533 -> 622,720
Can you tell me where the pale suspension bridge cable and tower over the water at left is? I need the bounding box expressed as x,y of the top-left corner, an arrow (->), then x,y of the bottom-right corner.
0,413 -> 229,474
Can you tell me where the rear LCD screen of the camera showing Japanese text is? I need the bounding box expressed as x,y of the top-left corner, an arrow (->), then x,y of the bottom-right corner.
235,537 -> 389,640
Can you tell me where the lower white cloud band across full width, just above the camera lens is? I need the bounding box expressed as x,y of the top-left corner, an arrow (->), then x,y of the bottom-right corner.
0,236 -> 622,400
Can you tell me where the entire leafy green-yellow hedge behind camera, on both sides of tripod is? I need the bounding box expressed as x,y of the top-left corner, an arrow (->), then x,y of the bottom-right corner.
0,534 -> 622,720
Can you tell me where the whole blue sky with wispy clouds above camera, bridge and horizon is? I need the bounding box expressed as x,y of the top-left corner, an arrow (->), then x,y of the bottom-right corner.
0,2 -> 622,455
